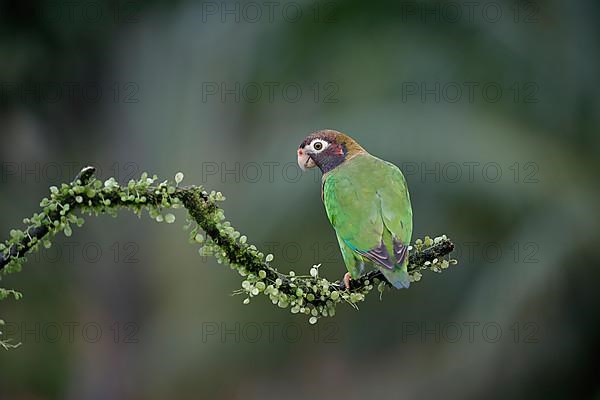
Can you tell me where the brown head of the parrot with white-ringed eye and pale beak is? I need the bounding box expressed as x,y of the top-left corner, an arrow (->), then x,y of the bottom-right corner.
298,129 -> 365,173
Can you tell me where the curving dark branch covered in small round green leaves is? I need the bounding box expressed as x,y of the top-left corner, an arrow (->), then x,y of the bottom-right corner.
0,167 -> 456,346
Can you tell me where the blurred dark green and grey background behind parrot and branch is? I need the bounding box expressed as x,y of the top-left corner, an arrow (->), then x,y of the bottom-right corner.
0,0 -> 600,399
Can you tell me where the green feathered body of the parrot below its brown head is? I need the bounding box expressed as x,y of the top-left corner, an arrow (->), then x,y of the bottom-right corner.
323,154 -> 412,287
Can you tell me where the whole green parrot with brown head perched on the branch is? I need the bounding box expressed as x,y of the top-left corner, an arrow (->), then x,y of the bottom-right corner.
298,129 -> 412,289
